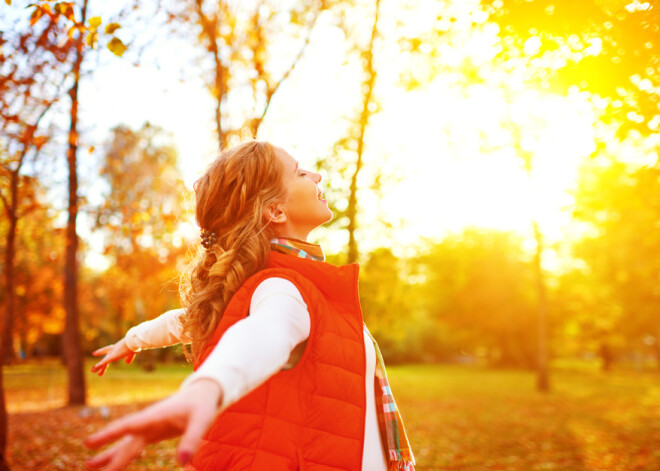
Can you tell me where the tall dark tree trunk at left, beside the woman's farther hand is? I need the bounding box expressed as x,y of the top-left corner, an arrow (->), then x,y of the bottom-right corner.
62,0 -> 87,405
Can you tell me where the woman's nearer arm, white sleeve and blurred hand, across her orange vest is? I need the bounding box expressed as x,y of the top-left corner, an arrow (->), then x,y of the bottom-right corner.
85,278 -> 310,471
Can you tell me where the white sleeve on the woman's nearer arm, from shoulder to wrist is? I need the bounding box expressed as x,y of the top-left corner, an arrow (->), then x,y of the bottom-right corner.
181,278 -> 310,410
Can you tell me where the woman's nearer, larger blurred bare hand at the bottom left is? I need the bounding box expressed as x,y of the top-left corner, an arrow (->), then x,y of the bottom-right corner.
84,378 -> 223,471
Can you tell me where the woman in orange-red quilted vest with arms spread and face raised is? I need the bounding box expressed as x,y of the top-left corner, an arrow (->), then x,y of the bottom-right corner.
85,141 -> 414,471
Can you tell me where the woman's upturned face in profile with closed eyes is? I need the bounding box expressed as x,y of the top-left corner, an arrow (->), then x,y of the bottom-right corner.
272,147 -> 332,240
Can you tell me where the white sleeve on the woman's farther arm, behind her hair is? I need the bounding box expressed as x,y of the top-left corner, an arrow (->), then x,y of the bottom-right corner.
124,309 -> 190,352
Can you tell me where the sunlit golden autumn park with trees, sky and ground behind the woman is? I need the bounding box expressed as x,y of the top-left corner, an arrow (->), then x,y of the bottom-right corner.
0,0 -> 660,471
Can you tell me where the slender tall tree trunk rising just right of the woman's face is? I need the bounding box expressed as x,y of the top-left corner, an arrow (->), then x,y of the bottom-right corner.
346,0 -> 380,263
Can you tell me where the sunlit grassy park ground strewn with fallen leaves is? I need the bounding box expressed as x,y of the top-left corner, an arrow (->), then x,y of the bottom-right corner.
5,363 -> 660,471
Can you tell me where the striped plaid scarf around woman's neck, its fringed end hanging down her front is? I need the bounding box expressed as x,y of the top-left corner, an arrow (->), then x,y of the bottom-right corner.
270,238 -> 415,471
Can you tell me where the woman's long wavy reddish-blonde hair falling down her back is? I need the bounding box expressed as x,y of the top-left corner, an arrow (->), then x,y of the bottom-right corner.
180,141 -> 286,360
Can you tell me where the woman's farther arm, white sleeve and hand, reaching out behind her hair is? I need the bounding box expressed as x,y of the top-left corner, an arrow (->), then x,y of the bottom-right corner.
92,309 -> 189,376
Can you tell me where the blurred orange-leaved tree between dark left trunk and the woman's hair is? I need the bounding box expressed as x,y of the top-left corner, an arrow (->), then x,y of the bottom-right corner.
91,123 -> 188,358
